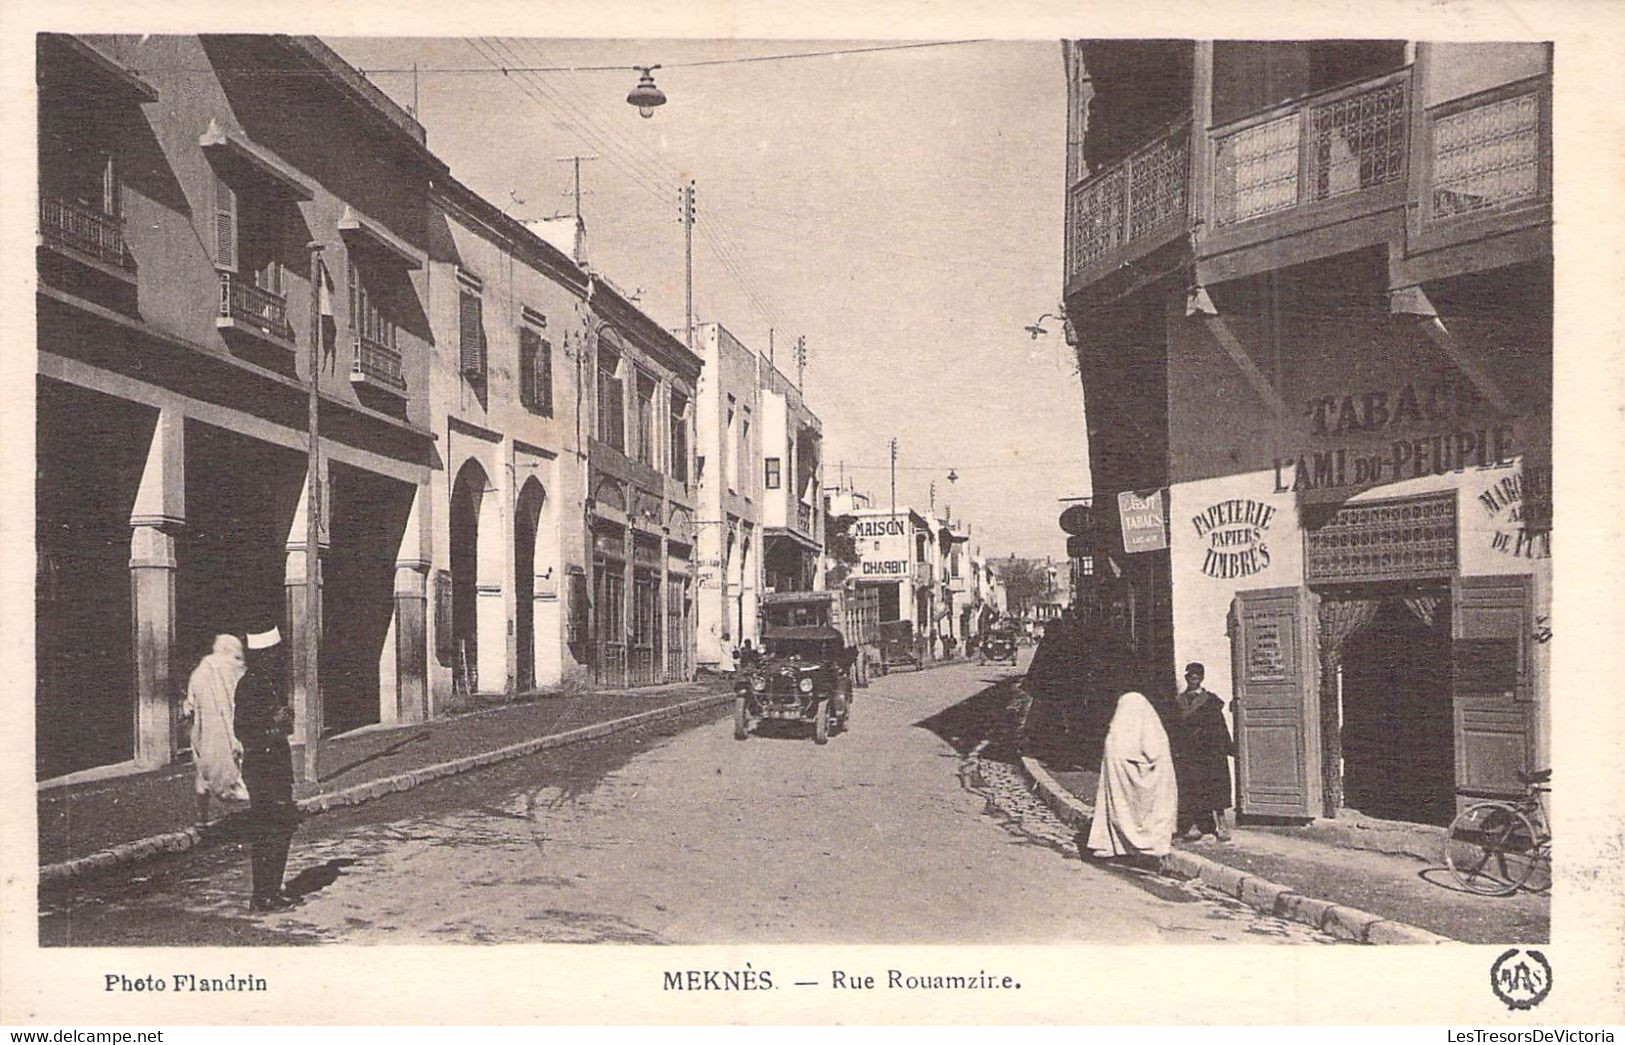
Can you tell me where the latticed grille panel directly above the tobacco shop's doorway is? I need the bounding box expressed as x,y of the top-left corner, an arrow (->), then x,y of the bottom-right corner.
1303,492 -> 1456,583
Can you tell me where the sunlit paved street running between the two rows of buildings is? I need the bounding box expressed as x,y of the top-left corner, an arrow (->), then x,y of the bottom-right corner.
41,657 -> 1329,944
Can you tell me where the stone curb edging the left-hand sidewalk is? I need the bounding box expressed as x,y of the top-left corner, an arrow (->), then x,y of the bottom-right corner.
39,692 -> 733,884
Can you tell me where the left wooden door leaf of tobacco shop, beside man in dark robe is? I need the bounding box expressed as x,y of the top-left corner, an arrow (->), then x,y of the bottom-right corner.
1230,588 -> 1321,817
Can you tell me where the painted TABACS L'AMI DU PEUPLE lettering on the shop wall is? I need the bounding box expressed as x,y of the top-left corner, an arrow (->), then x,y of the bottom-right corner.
1274,377 -> 1521,501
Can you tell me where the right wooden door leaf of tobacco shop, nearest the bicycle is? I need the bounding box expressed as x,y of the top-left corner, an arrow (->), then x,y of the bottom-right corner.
1450,575 -> 1541,803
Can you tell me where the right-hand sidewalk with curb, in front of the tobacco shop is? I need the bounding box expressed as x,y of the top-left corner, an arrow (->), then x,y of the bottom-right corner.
1022,757 -> 1552,944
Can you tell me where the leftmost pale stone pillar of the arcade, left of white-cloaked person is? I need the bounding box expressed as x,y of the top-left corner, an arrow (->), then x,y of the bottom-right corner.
130,410 -> 187,769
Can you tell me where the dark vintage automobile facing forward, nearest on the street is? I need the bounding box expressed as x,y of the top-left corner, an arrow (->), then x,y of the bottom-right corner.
733,624 -> 856,744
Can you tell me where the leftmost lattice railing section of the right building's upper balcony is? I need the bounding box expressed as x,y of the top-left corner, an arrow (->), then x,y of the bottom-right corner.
1066,125 -> 1191,278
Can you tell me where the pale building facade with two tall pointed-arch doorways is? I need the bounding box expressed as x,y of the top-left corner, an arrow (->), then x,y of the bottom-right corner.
413,176 -> 592,713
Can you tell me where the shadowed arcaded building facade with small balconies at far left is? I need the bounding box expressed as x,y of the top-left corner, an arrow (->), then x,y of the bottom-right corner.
36,34 -> 444,778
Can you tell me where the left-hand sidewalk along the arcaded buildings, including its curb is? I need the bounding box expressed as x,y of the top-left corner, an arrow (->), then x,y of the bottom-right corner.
37,678 -> 731,881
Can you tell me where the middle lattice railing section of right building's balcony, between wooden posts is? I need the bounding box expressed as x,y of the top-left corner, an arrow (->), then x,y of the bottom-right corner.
1212,70 -> 1411,228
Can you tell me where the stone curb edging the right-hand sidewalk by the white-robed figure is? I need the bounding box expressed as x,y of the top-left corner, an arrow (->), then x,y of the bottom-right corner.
1021,756 -> 1456,944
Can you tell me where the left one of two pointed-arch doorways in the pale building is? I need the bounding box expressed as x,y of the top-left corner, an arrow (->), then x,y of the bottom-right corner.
450,460 -> 507,694
